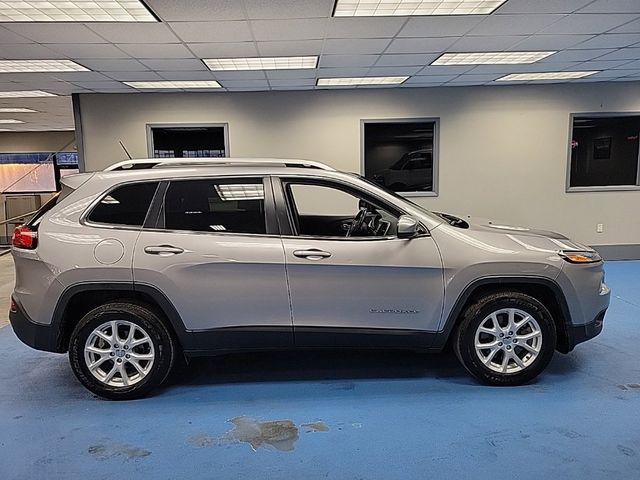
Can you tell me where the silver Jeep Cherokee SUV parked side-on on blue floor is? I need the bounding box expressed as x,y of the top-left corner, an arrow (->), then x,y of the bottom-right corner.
10,159 -> 610,399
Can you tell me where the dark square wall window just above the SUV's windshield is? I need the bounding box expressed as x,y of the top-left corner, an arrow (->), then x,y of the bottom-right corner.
364,121 -> 436,192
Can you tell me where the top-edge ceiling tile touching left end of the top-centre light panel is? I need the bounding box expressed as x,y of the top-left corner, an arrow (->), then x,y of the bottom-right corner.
244,0 -> 335,19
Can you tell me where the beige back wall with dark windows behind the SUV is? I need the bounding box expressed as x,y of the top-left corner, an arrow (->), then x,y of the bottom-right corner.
80,82 -> 640,245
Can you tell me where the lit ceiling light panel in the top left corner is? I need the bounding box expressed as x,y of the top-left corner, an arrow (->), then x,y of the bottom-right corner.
0,0 -> 158,22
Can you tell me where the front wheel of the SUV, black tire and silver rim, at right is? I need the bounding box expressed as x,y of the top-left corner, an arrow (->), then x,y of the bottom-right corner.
453,292 -> 557,386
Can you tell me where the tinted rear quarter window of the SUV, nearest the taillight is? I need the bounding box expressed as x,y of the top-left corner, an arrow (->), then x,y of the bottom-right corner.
88,182 -> 158,226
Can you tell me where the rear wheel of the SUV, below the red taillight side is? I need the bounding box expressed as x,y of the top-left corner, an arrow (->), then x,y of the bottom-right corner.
69,301 -> 176,400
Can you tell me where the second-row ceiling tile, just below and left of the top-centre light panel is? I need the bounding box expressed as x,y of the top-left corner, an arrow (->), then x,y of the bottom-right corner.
251,18 -> 328,41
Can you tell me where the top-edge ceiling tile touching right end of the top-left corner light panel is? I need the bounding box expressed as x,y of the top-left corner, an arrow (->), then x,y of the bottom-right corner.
146,0 -> 245,22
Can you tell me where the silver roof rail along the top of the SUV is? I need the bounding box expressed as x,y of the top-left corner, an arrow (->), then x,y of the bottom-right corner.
104,157 -> 335,172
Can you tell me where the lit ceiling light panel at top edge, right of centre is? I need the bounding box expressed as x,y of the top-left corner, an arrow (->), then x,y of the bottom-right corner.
333,0 -> 507,17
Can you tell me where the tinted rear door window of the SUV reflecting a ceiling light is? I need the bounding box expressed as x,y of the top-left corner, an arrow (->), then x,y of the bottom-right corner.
164,178 -> 266,233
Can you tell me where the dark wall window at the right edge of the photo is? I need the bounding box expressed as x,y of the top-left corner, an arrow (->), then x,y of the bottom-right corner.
569,116 -> 640,187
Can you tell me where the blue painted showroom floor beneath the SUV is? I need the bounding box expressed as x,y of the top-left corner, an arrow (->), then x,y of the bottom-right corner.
0,262 -> 640,480
